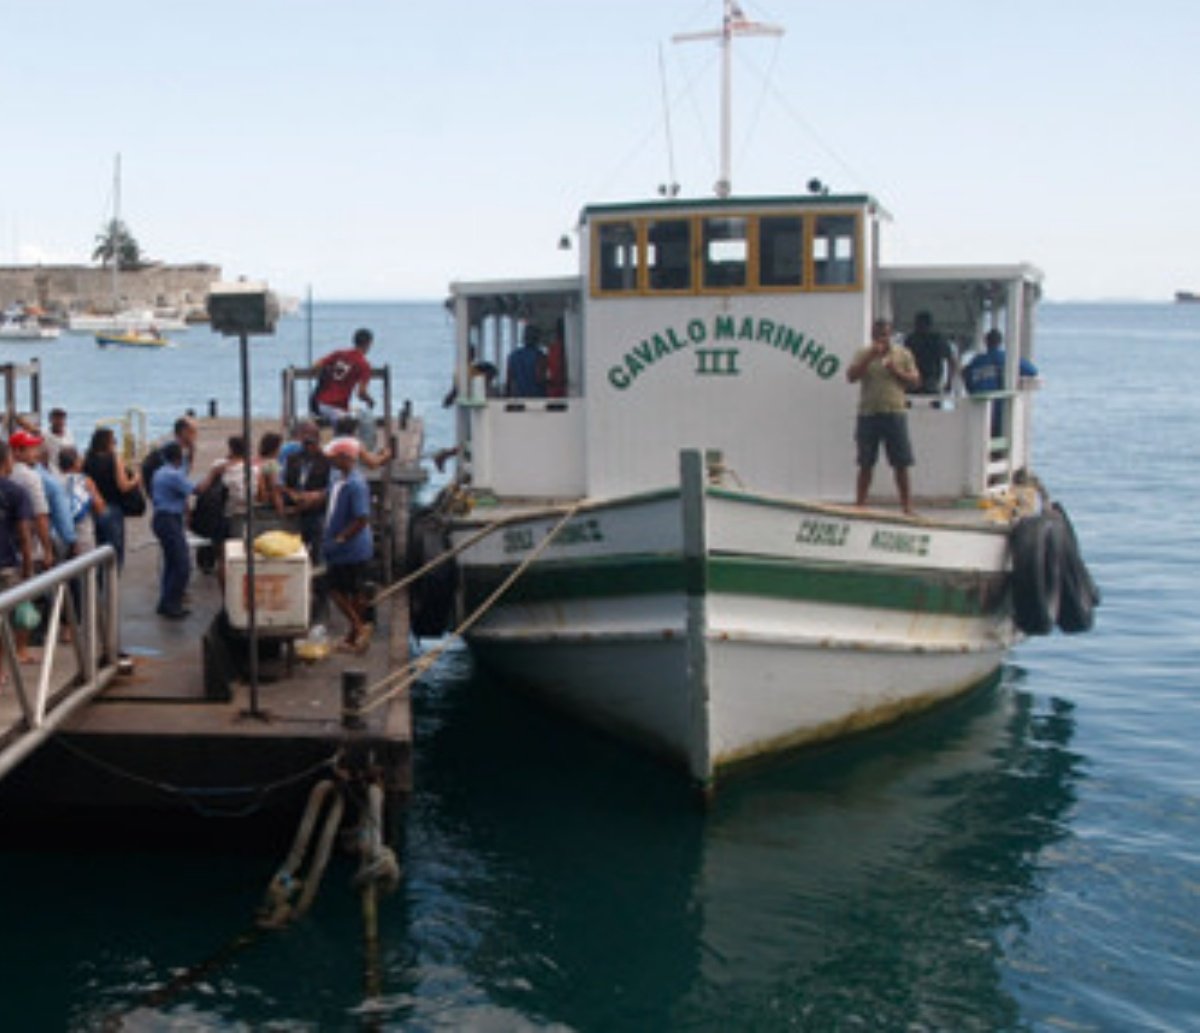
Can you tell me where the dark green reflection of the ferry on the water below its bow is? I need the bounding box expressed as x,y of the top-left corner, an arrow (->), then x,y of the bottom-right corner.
381,654 -> 1080,1029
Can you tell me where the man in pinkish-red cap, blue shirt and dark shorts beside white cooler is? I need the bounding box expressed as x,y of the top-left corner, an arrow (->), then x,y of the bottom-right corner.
322,439 -> 374,653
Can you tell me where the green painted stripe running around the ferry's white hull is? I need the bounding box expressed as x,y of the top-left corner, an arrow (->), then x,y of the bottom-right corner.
464,555 -> 1007,617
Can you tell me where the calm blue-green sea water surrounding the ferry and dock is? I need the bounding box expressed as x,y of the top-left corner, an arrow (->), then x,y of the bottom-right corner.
0,298 -> 1200,1031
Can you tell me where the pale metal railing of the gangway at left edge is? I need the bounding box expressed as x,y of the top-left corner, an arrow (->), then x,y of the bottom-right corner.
0,546 -> 120,777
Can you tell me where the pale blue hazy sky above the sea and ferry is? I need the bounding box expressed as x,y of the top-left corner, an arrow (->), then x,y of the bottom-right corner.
0,0 -> 1200,300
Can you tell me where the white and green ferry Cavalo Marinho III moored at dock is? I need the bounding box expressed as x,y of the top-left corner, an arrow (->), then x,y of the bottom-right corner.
429,2 -> 1098,791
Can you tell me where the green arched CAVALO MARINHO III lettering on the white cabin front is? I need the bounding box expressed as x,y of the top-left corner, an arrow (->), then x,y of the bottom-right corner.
608,316 -> 841,391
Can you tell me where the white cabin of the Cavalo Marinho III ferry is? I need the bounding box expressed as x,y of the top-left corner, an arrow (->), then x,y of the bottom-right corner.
451,196 -> 1039,502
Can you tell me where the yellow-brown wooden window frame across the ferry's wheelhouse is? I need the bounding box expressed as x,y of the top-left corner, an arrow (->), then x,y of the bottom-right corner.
588,208 -> 865,299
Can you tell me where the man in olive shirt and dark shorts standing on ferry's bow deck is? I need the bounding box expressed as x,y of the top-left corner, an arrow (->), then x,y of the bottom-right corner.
846,319 -> 920,514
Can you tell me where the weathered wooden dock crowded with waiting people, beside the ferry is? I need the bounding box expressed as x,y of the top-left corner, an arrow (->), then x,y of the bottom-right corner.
0,419 -> 424,830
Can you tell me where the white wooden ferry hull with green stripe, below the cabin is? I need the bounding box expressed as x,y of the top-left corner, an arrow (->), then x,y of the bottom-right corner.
460,455 -> 1014,783
